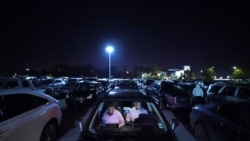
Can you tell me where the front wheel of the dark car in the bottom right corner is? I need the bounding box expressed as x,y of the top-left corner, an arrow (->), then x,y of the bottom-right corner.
194,123 -> 209,141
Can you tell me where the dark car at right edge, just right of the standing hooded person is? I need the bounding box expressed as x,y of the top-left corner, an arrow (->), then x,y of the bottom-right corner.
207,84 -> 250,103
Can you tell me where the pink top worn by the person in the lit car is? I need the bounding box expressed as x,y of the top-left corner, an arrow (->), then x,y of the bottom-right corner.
102,109 -> 125,125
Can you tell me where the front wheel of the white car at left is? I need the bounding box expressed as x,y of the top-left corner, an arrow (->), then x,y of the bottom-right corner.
41,122 -> 57,141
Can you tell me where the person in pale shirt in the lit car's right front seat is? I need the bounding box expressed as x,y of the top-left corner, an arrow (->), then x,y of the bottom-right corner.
126,102 -> 148,123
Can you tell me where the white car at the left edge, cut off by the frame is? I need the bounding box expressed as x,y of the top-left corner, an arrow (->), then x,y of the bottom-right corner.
0,89 -> 62,141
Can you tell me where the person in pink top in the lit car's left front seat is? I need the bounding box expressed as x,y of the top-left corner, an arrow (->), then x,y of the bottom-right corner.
101,103 -> 125,128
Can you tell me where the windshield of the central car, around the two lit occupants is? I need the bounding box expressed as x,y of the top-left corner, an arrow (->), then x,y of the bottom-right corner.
88,101 -> 168,135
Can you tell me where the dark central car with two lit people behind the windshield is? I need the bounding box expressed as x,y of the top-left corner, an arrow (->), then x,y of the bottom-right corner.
78,89 -> 178,141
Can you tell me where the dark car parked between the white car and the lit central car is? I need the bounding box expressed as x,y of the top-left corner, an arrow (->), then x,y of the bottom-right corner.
65,81 -> 104,107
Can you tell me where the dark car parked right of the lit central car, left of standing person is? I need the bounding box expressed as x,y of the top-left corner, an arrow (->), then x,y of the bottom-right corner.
146,80 -> 192,110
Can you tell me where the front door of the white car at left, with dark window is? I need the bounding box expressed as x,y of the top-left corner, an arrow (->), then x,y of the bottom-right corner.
1,94 -> 48,141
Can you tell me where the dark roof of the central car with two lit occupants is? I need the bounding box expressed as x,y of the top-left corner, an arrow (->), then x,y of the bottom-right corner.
102,89 -> 153,101
